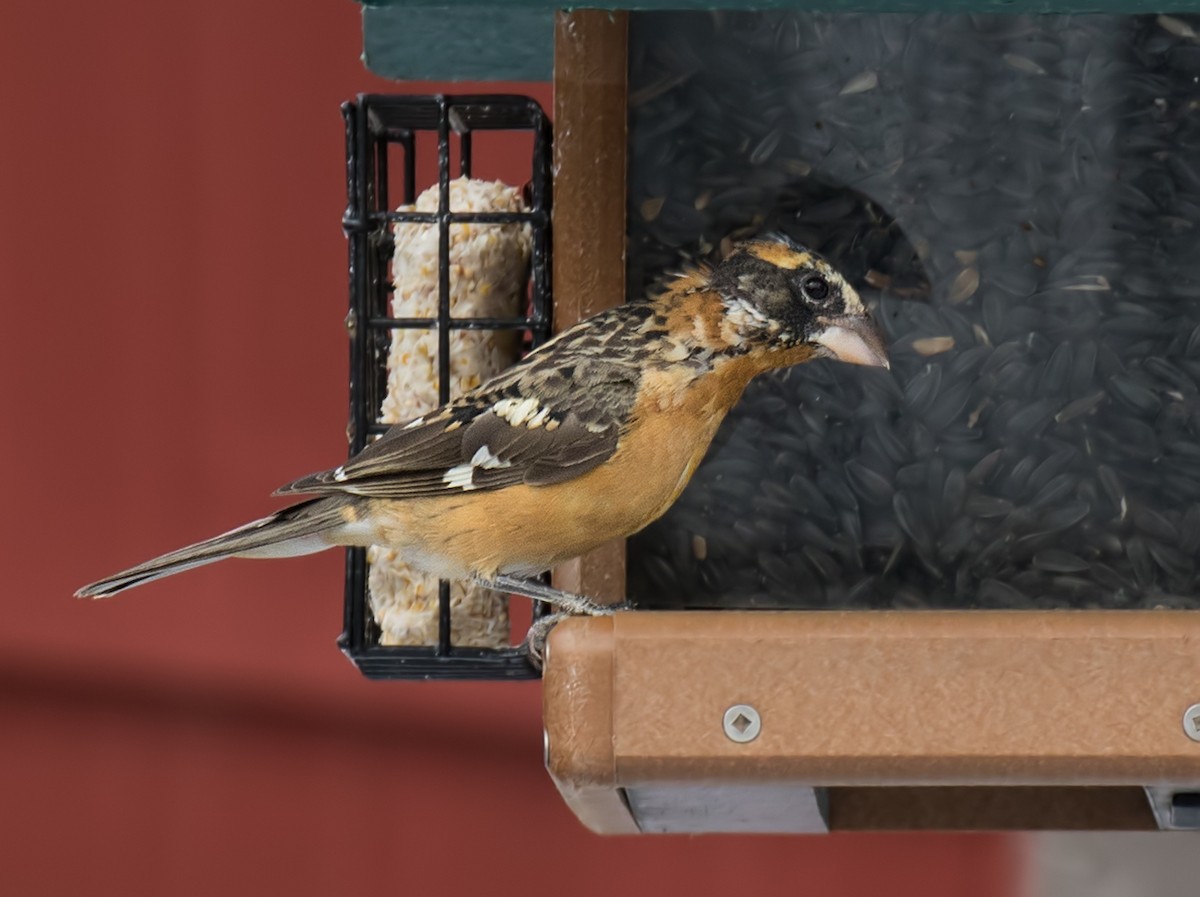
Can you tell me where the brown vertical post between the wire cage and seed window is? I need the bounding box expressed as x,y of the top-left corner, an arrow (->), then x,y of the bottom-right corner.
553,10 -> 629,603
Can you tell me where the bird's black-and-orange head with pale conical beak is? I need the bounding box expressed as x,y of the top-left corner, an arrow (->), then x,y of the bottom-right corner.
709,236 -> 889,368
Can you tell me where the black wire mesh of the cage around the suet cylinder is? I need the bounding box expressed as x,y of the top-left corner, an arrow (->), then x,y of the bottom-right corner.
338,95 -> 551,679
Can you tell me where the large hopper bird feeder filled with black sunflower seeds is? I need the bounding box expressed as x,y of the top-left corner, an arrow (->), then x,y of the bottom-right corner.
348,0 -> 1200,832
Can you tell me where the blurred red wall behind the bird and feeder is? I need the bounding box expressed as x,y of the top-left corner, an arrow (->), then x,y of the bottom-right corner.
0,0 -> 1013,897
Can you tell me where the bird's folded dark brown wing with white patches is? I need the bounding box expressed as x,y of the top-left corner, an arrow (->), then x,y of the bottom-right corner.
277,317 -> 641,498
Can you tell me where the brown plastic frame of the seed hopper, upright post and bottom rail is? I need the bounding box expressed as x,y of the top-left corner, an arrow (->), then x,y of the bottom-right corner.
544,11 -> 1200,833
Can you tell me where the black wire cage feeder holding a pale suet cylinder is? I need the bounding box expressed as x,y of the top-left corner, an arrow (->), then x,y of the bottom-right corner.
340,95 -> 551,679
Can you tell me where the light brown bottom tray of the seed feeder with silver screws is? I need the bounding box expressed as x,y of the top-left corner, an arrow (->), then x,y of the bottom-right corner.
544,610 -> 1200,833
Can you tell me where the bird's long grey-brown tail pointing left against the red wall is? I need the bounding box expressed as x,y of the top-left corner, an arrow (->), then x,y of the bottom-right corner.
76,498 -> 347,598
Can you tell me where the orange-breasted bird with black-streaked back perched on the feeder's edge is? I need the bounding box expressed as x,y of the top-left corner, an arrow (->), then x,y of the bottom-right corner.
76,235 -> 889,642
